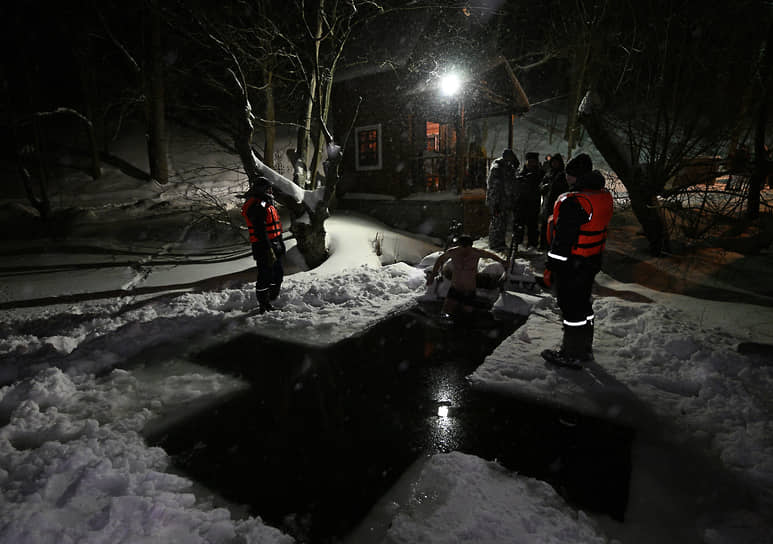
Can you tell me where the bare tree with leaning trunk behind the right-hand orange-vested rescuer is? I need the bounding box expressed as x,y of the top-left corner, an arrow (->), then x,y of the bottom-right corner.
564,0 -> 767,255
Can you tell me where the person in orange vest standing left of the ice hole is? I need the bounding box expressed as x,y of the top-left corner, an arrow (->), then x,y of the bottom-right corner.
242,177 -> 286,313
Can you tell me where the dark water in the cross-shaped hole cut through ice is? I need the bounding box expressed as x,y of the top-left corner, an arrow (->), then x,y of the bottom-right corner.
149,311 -> 632,542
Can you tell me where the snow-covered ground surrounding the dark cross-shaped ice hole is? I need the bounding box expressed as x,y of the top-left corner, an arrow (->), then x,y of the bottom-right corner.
0,124 -> 773,544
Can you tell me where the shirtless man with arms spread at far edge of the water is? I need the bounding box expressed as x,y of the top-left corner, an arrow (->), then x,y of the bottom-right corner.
427,234 -> 507,318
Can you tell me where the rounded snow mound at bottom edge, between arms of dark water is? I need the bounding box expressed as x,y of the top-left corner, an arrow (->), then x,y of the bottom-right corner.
385,452 -> 607,544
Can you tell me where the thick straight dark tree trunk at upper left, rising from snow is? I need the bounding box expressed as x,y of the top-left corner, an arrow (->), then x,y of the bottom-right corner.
142,0 -> 169,183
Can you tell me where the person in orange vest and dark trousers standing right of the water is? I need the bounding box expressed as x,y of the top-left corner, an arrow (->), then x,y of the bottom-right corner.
542,153 -> 613,368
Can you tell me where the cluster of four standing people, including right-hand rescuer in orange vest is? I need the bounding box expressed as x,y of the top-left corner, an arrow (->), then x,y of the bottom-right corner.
486,149 -> 613,368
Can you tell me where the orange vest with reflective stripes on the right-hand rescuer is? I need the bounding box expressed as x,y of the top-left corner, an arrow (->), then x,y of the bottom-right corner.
546,189 -> 614,257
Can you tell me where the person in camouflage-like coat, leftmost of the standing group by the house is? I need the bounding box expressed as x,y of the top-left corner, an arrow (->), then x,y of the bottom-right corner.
486,149 -> 519,251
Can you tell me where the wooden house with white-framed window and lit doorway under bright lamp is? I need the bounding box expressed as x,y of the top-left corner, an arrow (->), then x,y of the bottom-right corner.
333,57 -> 529,235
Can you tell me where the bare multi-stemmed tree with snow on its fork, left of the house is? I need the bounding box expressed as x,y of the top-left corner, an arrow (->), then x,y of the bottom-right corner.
176,0 -> 408,267
